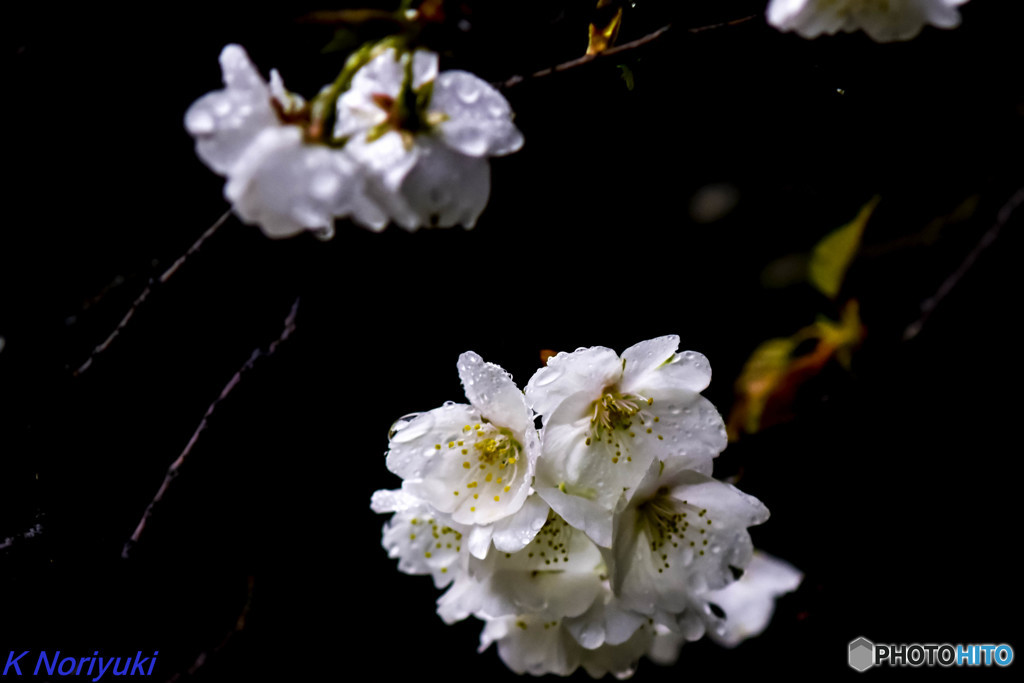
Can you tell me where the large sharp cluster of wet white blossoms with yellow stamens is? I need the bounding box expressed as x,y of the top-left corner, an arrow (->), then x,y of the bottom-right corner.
372,336 -> 801,678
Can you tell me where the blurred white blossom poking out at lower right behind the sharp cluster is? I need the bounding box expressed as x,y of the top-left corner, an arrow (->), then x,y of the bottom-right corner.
705,551 -> 804,647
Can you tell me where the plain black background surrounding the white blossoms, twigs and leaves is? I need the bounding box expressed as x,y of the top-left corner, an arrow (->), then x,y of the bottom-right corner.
0,0 -> 1024,681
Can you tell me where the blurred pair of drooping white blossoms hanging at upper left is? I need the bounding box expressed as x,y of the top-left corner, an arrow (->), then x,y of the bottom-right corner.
185,43 -> 522,238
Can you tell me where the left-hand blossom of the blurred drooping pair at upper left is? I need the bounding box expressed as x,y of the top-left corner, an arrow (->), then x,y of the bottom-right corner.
185,45 -> 388,238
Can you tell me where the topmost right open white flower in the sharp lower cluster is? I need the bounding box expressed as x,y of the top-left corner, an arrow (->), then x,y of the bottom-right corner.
526,335 -> 726,548
